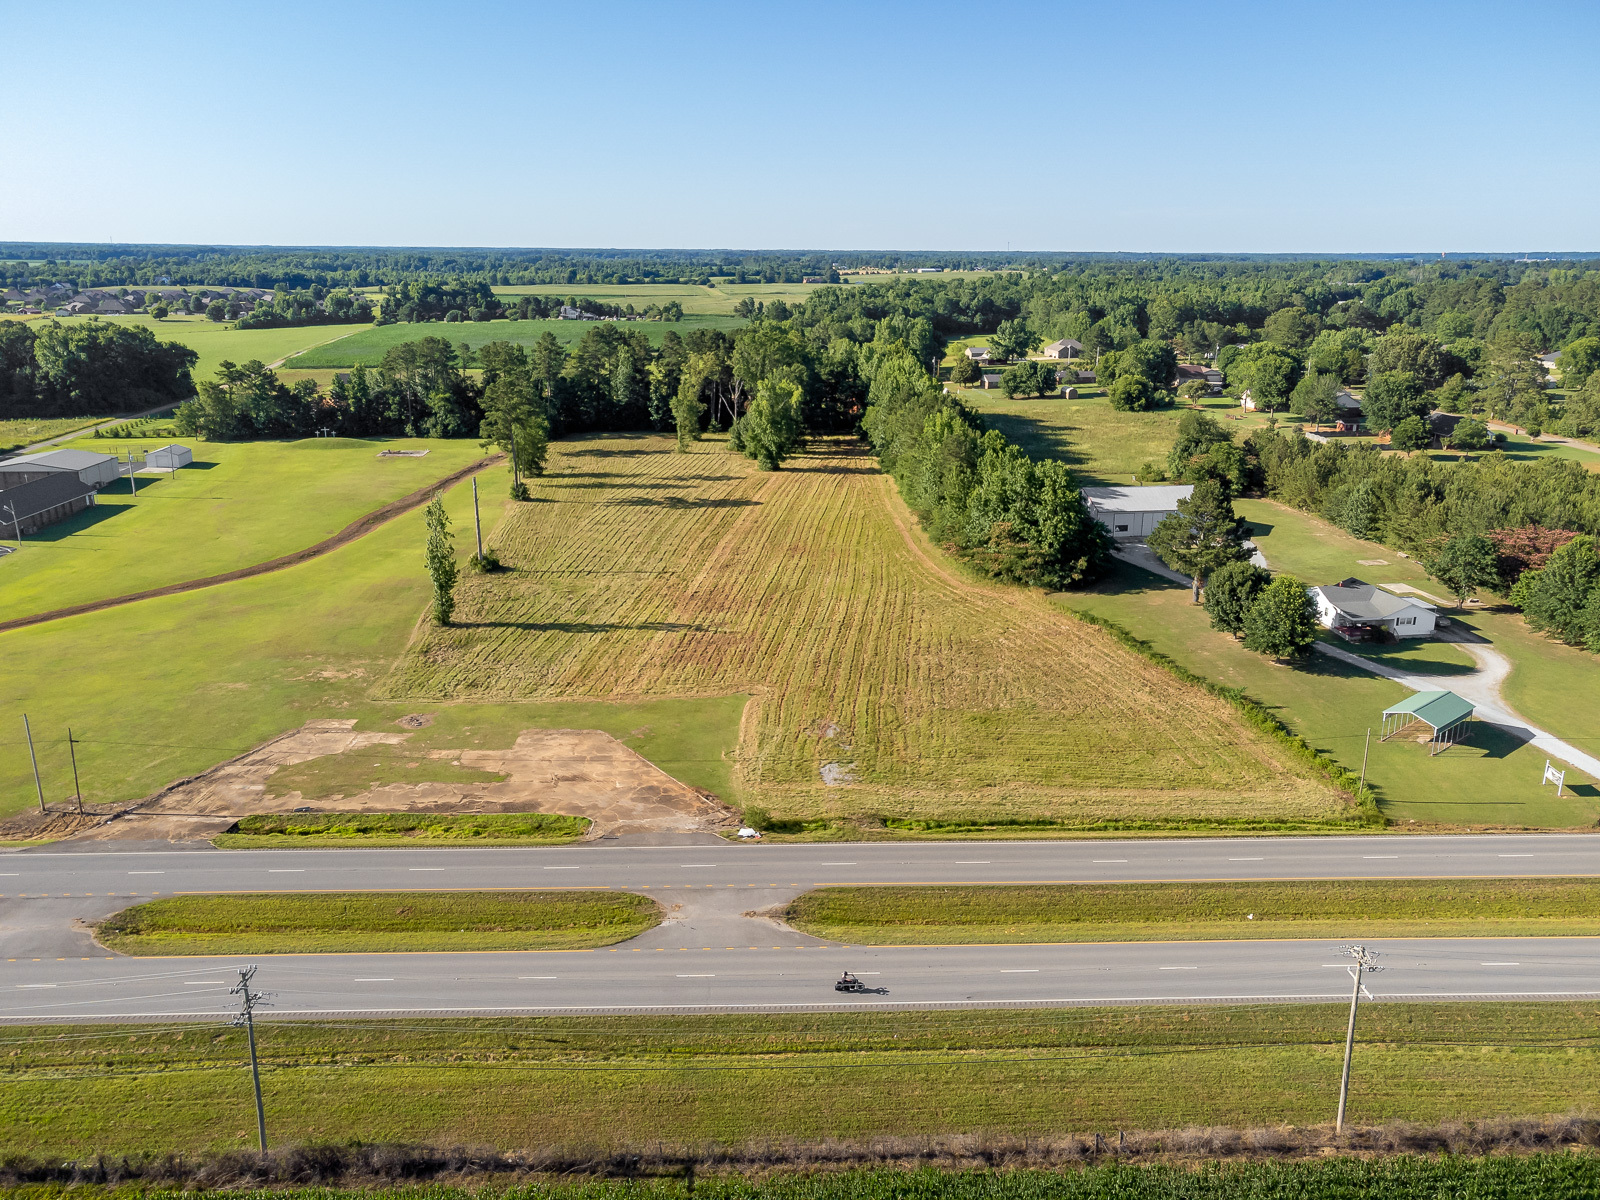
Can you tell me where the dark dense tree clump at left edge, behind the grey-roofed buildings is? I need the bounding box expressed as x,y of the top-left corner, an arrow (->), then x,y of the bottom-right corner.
0,320 -> 198,418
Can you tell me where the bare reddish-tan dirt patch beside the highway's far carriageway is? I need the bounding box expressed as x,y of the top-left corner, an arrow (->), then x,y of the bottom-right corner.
64,715 -> 736,840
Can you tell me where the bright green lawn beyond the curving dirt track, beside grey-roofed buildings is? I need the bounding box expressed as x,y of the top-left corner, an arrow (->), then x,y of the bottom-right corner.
0,438 -> 489,616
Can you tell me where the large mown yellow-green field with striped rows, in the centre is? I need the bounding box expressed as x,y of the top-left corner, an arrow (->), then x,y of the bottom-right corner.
382,435 -> 1342,826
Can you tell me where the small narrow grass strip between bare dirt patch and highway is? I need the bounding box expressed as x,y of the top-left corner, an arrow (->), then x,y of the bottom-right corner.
211,812 -> 589,850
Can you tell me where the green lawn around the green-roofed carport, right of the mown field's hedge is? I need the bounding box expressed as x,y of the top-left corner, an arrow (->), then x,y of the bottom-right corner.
1053,569 -> 1600,829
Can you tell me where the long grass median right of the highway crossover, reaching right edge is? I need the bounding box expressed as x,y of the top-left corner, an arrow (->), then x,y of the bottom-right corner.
787,878 -> 1600,946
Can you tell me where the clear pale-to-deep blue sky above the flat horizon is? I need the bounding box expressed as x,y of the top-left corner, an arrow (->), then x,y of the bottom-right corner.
0,0 -> 1600,253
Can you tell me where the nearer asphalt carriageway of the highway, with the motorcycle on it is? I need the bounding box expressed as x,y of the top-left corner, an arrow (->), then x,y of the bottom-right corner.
0,938 -> 1600,1022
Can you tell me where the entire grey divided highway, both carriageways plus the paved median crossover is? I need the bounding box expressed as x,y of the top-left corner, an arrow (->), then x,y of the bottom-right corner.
0,835 -> 1600,1021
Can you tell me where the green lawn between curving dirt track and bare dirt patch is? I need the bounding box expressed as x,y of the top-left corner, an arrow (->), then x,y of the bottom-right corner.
0,454 -> 746,816
